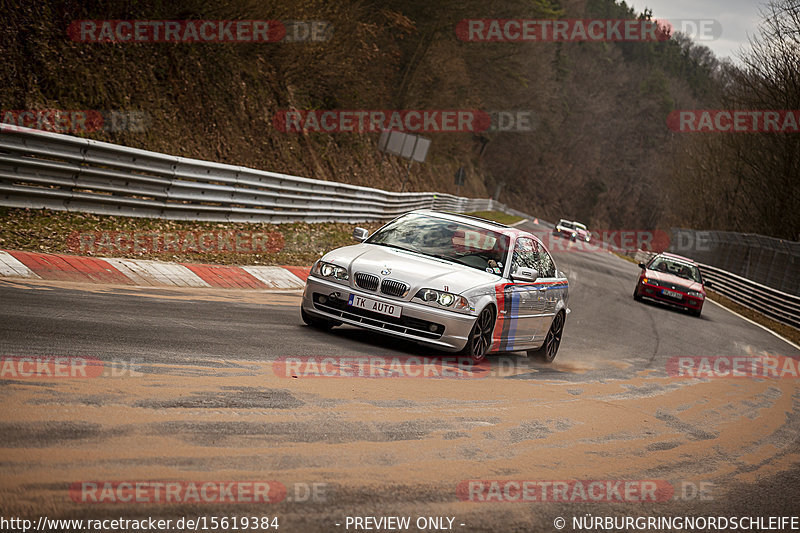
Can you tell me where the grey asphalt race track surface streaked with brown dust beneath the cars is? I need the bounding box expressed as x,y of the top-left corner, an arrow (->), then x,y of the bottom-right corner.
0,218 -> 800,531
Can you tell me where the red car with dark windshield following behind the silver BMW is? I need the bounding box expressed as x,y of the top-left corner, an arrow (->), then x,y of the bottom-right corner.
633,252 -> 711,316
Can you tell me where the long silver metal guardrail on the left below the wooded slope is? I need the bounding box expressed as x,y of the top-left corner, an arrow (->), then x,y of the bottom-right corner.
0,125 -> 508,223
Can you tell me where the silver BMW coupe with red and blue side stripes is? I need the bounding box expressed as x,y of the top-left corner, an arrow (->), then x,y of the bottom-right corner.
301,211 -> 569,362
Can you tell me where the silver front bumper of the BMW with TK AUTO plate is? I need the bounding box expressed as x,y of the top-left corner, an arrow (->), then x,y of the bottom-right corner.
301,275 -> 477,352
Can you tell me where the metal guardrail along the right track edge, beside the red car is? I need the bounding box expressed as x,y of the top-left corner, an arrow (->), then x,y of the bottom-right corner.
626,250 -> 800,329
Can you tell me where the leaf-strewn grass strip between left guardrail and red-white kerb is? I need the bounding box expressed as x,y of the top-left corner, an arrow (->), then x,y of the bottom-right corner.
0,208 -> 381,265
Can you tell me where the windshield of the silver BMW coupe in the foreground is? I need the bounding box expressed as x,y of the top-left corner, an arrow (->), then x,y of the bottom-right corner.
366,214 -> 509,275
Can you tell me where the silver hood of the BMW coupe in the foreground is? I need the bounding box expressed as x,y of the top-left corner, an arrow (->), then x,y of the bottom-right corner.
322,243 -> 500,300
